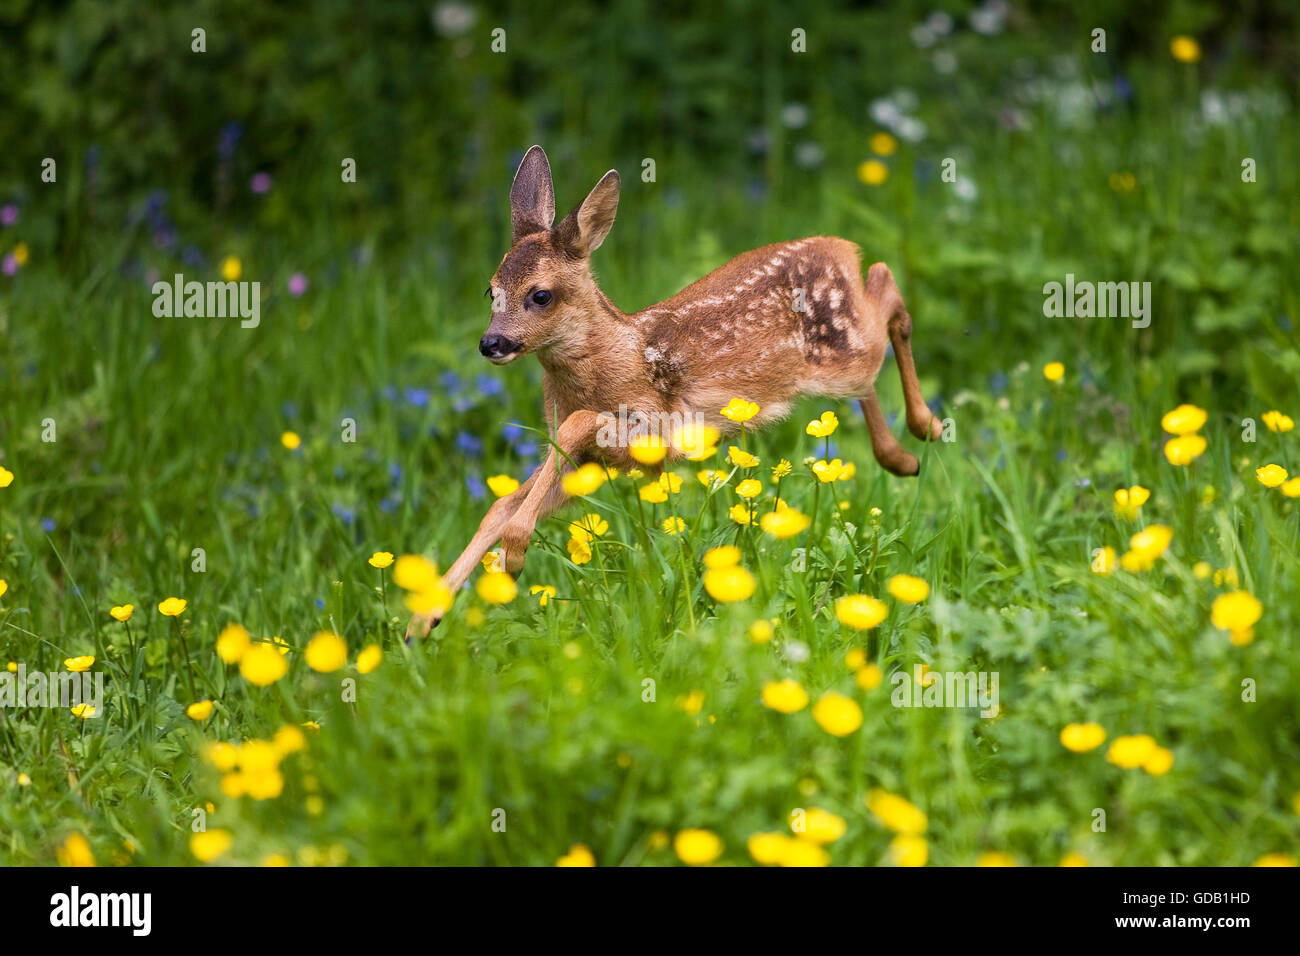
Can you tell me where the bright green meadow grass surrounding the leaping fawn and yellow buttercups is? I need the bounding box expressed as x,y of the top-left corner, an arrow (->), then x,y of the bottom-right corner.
0,50 -> 1300,865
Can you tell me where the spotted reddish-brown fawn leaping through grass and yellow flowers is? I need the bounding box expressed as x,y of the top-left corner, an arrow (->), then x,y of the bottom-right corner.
407,146 -> 943,636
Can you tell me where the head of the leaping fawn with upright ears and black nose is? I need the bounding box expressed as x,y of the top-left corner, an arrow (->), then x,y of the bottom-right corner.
478,146 -> 619,365
